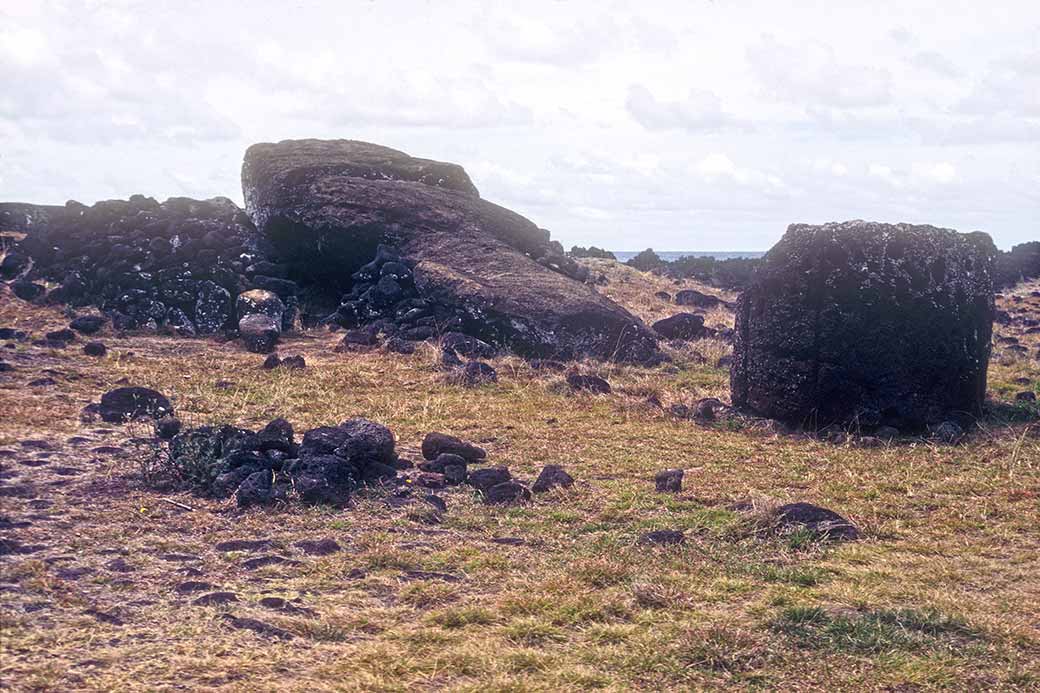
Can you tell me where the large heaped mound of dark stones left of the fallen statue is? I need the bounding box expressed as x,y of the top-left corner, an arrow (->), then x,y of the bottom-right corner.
3,195 -> 268,335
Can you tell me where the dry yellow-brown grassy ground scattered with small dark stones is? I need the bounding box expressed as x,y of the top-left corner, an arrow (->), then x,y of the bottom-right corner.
0,260 -> 1040,691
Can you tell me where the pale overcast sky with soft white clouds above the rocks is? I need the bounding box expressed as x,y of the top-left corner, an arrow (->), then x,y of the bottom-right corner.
0,0 -> 1040,250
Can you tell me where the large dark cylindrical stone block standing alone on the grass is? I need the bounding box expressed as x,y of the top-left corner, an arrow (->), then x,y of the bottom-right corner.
730,222 -> 996,429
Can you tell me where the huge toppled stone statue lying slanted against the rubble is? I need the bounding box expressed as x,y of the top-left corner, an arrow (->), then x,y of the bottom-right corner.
242,139 -> 659,362
